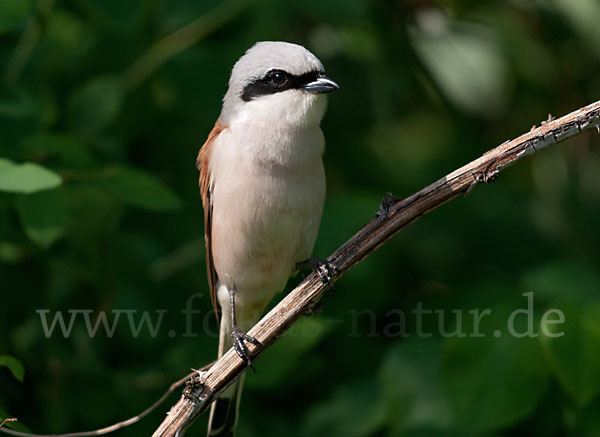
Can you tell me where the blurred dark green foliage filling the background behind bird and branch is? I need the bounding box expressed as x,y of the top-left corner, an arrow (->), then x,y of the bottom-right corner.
0,0 -> 600,436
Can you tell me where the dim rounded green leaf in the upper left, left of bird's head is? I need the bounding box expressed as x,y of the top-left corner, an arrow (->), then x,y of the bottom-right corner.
69,76 -> 123,133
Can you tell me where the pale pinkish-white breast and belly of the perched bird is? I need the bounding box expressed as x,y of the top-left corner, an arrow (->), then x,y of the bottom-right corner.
210,99 -> 325,323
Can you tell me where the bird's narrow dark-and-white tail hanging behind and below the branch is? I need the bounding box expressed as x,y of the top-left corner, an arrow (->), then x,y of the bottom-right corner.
207,317 -> 244,437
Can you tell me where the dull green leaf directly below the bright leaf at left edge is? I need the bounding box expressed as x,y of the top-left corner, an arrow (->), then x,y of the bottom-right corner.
17,190 -> 68,248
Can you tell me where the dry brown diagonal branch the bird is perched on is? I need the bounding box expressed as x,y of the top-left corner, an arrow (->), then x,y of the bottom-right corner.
153,101 -> 600,437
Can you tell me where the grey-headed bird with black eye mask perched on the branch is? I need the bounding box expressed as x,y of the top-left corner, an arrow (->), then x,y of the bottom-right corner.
196,41 -> 339,437
